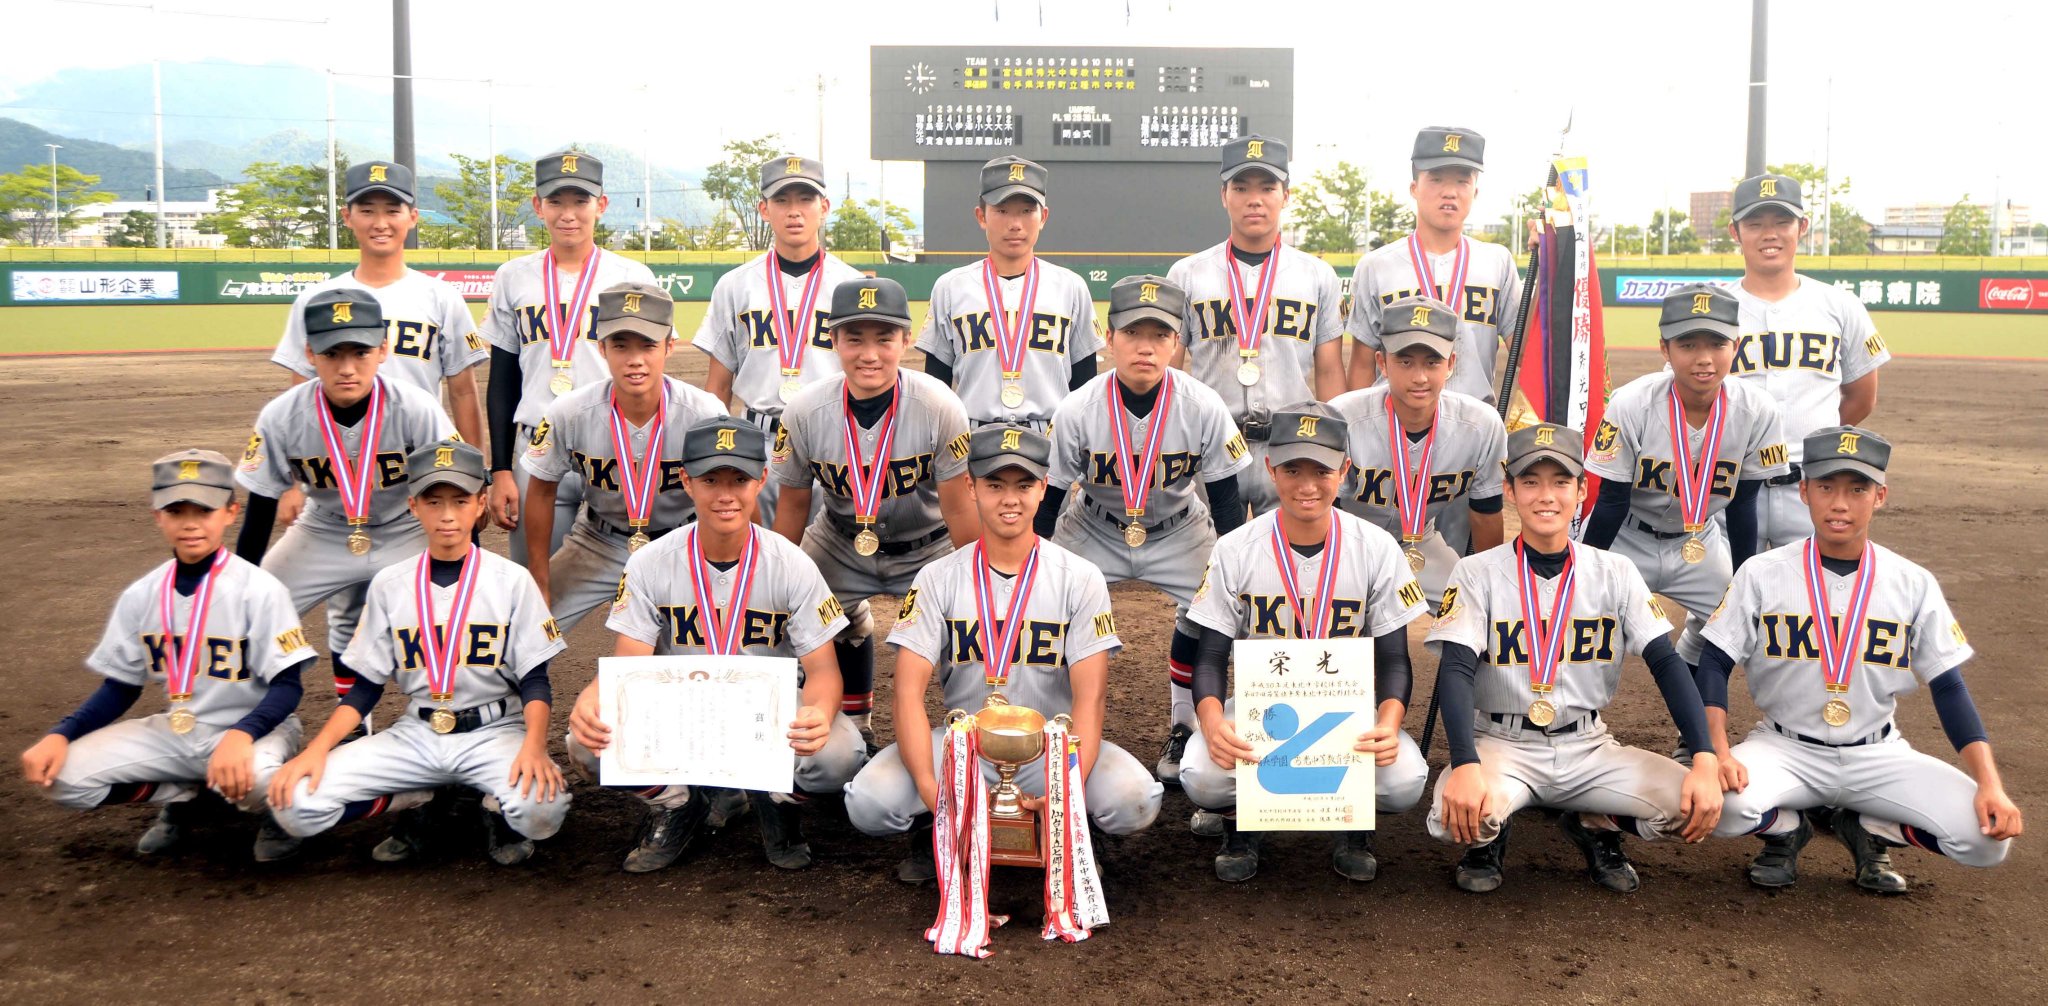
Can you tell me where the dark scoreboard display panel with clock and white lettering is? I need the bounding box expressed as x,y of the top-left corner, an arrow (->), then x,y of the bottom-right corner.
870,45 -> 1294,162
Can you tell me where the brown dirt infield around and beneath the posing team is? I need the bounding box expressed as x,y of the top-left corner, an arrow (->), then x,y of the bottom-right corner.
0,352 -> 2048,1004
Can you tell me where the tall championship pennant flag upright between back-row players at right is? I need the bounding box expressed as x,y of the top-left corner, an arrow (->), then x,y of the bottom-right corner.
1507,158 -> 1612,531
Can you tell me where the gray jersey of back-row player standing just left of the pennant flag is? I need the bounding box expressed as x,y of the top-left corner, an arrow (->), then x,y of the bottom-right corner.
1346,238 -> 1522,406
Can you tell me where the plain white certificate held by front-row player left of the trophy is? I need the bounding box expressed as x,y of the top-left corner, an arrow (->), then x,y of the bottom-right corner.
598,656 -> 799,793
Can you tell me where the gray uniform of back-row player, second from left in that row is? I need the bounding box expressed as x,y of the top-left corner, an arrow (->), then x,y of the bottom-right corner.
479,250 -> 655,565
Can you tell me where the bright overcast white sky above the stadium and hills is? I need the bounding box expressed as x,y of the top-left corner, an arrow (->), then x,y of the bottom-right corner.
0,0 -> 2048,221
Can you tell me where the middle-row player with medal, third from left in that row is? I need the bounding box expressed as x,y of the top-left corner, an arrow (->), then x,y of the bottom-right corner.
774,279 -> 981,731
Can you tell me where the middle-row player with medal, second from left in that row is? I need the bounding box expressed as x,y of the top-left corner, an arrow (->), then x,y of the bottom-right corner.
524,283 -> 725,633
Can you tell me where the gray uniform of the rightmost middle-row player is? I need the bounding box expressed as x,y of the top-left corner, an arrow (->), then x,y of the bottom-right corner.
1585,371 -> 1790,664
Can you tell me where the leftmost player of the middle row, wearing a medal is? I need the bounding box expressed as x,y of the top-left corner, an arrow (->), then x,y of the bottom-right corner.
236,289 -> 455,711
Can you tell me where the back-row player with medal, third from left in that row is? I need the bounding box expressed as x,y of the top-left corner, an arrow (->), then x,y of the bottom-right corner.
690,156 -> 862,527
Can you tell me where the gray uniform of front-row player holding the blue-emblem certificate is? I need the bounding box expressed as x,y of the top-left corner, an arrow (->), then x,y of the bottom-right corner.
1180,510 -> 1430,813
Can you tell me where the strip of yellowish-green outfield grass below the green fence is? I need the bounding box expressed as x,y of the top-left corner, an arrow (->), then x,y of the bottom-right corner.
0,301 -> 2048,361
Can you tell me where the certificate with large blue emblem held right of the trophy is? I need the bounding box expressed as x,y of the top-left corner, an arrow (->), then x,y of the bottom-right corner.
1231,639 -> 1378,832
